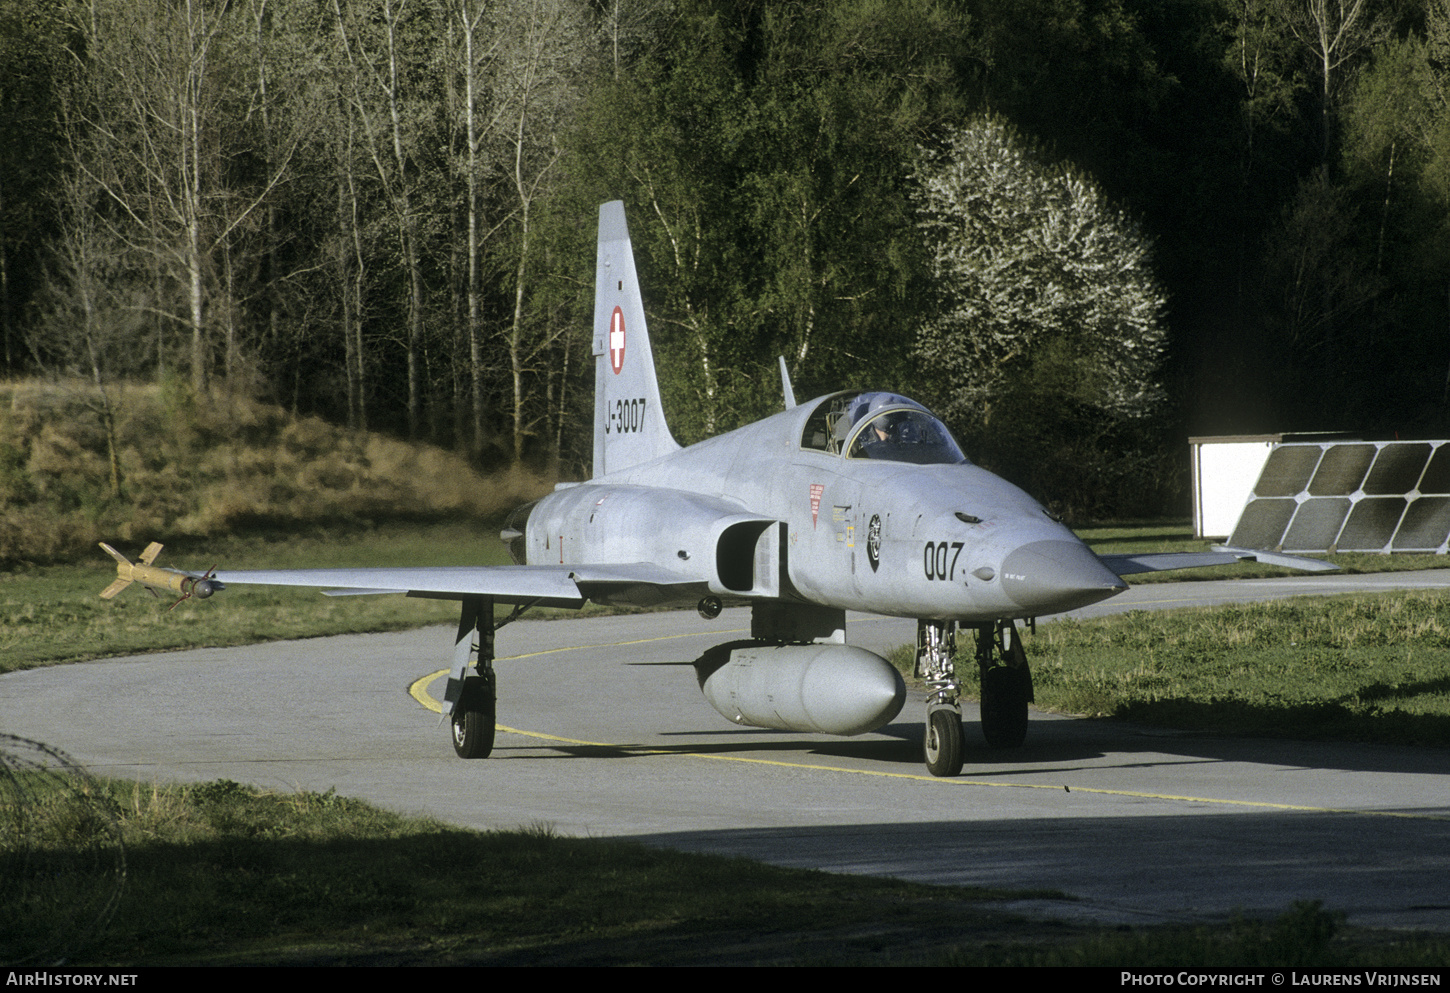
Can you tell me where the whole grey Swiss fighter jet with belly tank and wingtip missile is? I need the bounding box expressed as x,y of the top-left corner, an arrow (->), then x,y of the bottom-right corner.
96,201 -> 1333,776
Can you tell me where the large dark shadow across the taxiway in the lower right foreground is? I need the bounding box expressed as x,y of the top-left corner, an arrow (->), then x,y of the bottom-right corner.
631,811 -> 1450,931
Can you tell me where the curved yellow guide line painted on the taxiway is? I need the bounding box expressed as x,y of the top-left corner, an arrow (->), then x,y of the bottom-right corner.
407,672 -> 1450,820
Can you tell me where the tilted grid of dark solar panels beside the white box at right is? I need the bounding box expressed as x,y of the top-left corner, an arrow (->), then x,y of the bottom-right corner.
1228,441 -> 1450,554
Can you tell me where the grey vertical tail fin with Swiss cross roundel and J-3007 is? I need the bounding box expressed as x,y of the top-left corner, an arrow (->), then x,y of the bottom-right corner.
595,200 -> 680,478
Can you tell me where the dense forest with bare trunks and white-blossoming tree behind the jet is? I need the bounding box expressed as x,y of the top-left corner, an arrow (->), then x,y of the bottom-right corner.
0,0 -> 1450,516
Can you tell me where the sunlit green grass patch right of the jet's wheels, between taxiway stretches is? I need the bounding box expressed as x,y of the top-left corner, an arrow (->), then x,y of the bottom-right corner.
1020,591 -> 1450,747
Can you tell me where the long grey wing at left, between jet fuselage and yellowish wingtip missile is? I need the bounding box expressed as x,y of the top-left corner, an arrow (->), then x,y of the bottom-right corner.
213,562 -> 699,607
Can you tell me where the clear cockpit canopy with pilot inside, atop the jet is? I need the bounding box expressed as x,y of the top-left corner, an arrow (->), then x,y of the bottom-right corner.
800,391 -> 967,465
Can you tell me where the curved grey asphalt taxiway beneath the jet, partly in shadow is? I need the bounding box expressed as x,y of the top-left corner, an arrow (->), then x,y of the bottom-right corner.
0,571 -> 1450,931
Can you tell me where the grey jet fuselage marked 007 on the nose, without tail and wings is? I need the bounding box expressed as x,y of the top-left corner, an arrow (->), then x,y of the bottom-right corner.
526,394 -> 1125,622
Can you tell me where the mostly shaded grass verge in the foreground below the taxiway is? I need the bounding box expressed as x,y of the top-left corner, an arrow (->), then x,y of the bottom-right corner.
0,780 -> 1450,967
